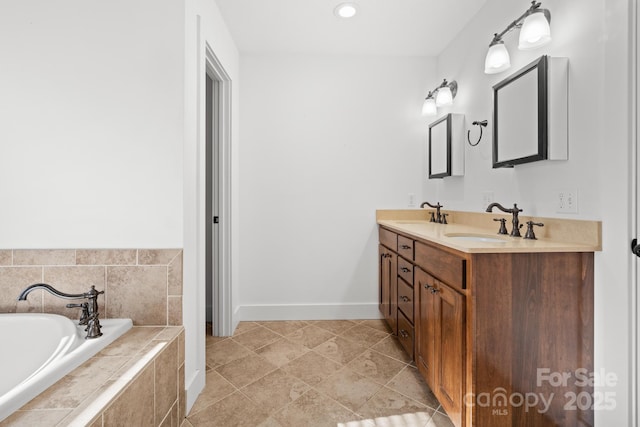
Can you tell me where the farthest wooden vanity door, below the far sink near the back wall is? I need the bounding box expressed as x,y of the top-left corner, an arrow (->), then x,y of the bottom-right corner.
378,245 -> 398,334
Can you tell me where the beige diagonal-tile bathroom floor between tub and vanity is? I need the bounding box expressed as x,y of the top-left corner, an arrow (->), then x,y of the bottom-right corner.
182,320 -> 453,427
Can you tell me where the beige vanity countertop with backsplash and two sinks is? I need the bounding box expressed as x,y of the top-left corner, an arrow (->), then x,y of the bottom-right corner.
376,209 -> 602,253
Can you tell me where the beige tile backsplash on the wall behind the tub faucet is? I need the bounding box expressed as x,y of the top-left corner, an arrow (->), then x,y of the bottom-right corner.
0,249 -> 182,326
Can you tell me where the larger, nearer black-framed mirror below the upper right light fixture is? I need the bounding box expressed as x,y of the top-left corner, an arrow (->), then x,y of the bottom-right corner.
493,55 -> 548,168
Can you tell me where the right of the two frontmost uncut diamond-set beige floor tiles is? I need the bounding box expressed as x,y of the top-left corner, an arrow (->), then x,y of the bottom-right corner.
316,368 -> 383,411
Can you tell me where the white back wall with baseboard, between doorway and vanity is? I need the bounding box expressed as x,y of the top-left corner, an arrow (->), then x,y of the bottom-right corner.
239,54 -> 436,319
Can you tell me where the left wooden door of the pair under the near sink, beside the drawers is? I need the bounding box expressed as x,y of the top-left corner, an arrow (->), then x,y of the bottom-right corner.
414,268 -> 437,390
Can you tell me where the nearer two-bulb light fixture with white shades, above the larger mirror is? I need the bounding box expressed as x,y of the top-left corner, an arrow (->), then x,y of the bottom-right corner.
484,0 -> 551,74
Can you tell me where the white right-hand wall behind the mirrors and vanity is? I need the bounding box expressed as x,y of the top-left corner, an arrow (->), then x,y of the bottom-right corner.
432,0 -> 634,425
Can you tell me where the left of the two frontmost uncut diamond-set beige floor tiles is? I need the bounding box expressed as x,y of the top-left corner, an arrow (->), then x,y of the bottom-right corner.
242,369 -> 310,414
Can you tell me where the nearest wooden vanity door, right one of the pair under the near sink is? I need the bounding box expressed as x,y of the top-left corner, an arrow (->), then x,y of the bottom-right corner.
433,281 -> 465,425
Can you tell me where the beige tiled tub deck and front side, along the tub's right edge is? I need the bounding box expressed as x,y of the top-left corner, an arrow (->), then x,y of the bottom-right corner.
0,326 -> 186,427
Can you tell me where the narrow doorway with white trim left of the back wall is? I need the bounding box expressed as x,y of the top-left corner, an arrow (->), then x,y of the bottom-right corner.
201,45 -> 233,336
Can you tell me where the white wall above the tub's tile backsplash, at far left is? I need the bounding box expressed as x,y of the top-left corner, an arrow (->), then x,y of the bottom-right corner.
0,0 -> 184,248
